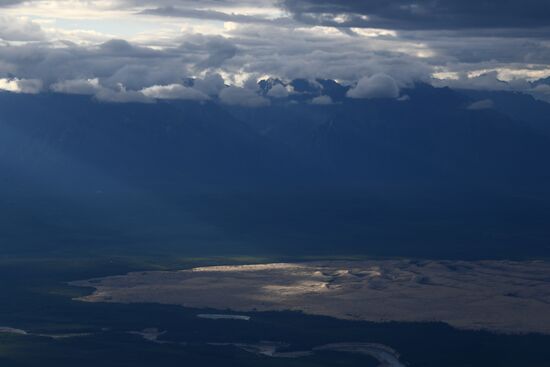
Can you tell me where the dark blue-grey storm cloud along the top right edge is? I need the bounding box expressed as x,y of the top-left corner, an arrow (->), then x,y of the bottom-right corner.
281,0 -> 550,30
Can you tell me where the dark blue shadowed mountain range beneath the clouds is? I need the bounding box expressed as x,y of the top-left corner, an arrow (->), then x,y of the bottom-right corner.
0,79 -> 550,256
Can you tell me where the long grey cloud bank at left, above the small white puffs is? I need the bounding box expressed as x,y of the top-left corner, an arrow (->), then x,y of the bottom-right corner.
0,36 -> 235,94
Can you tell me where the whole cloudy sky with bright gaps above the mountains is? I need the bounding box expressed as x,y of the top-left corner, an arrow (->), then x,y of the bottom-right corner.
0,0 -> 550,104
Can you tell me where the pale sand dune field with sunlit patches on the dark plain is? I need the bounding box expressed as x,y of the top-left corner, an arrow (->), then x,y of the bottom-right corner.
72,260 -> 550,334
